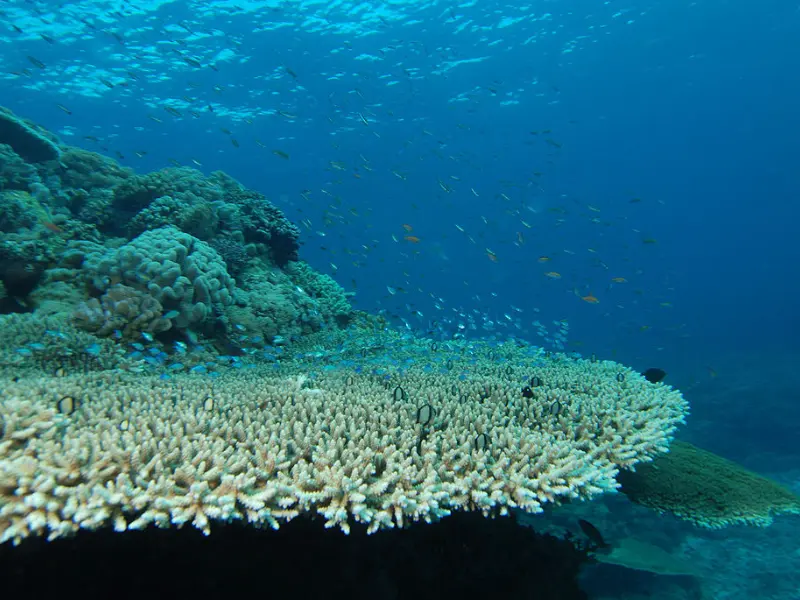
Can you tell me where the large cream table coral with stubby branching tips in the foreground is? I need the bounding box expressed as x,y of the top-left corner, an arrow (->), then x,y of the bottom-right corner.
0,359 -> 687,543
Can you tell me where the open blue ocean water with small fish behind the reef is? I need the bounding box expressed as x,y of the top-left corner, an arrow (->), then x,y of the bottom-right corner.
0,0 -> 800,599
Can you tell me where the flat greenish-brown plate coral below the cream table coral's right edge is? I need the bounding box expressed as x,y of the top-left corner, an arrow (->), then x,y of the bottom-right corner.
617,441 -> 800,529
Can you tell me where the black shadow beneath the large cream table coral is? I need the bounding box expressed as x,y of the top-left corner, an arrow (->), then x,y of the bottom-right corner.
0,514 -> 587,600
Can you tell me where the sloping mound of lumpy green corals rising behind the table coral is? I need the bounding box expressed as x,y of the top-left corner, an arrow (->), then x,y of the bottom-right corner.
0,110 -> 351,352
